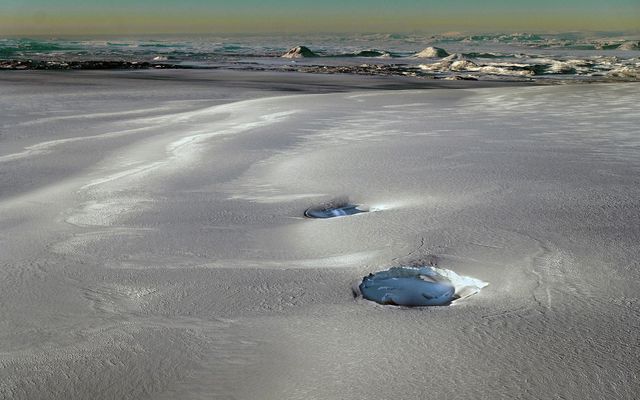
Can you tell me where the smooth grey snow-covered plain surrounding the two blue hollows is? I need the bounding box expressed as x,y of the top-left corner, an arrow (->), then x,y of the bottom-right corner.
0,71 -> 640,399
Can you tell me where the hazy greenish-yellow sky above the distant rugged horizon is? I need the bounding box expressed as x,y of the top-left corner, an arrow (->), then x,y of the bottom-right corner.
0,0 -> 640,35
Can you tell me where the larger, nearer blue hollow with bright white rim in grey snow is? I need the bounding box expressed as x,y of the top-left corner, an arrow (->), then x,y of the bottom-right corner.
358,266 -> 488,307
